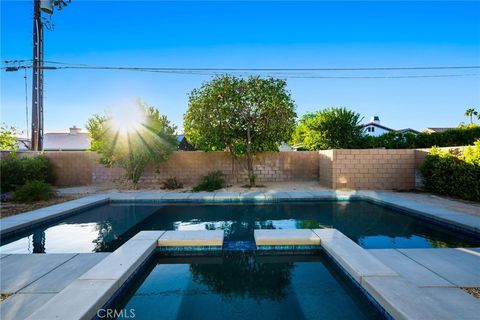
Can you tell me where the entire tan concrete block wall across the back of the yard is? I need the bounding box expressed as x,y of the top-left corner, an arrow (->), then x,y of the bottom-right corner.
0,147 -> 465,190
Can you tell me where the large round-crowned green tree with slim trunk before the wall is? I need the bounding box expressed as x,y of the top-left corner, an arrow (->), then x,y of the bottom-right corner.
184,75 -> 296,186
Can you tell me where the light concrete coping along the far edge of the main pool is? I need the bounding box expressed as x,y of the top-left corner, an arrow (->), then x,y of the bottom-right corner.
0,191 -> 480,238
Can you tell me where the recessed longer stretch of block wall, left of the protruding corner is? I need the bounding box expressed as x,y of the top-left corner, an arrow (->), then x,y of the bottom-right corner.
1,151 -> 319,186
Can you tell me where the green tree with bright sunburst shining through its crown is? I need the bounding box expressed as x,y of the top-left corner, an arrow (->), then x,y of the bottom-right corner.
86,100 -> 177,188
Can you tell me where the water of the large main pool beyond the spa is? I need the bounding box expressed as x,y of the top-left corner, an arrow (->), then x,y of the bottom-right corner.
0,201 -> 480,253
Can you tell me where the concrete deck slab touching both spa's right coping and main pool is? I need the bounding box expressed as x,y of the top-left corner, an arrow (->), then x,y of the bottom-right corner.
367,249 -> 455,287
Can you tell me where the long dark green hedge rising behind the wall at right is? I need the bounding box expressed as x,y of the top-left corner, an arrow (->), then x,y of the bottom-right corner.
362,125 -> 480,149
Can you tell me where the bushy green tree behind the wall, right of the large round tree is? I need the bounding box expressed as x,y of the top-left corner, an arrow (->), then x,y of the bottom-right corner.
292,108 -> 363,150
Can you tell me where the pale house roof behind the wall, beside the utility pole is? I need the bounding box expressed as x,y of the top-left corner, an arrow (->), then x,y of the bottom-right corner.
43,132 -> 90,151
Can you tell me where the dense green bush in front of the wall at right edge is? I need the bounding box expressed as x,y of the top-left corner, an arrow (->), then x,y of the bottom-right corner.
420,140 -> 480,201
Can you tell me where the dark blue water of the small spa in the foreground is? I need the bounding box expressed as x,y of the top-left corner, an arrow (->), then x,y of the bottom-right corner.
114,252 -> 382,320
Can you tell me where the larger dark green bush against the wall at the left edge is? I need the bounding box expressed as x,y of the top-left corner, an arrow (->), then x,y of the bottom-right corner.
0,155 -> 54,192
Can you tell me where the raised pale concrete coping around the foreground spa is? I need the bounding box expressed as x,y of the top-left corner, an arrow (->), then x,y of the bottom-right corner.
22,229 -> 478,319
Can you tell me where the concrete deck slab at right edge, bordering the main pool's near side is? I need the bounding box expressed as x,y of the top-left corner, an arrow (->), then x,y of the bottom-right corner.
399,248 -> 480,287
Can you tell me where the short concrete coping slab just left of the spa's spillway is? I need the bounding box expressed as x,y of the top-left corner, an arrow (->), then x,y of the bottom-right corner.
158,230 -> 223,247
